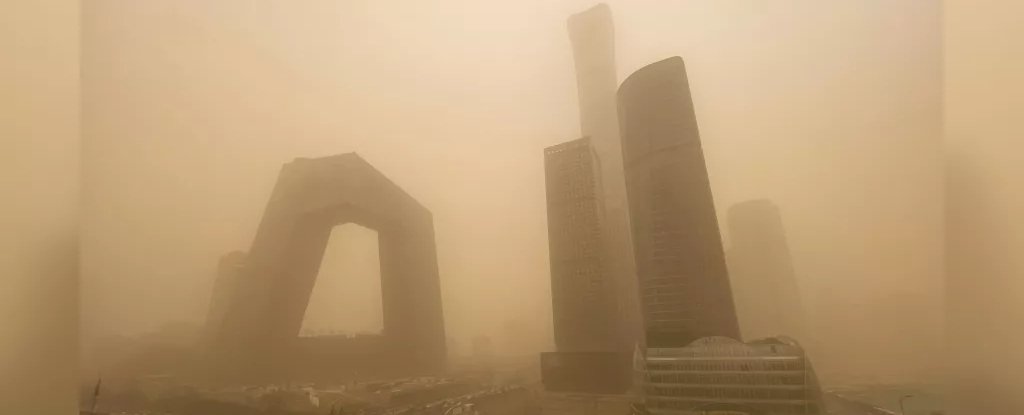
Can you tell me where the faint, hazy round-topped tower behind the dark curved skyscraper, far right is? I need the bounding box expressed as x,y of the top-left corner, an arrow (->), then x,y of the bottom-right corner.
728,200 -> 804,340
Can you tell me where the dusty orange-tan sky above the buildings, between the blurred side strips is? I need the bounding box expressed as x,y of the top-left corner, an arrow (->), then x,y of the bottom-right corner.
82,0 -> 942,381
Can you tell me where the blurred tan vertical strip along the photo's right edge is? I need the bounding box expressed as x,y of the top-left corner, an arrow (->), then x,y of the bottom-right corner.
943,0 -> 1024,407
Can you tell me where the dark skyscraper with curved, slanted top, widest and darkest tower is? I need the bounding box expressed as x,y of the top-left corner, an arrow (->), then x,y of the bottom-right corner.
618,56 -> 739,347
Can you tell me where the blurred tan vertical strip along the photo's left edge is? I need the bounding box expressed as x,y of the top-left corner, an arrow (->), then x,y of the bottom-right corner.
0,0 -> 80,415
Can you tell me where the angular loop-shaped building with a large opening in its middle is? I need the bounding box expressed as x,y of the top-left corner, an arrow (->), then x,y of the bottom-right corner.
210,153 -> 446,378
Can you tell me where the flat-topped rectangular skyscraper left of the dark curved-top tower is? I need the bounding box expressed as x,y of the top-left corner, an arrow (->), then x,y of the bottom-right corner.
541,137 -> 631,393
